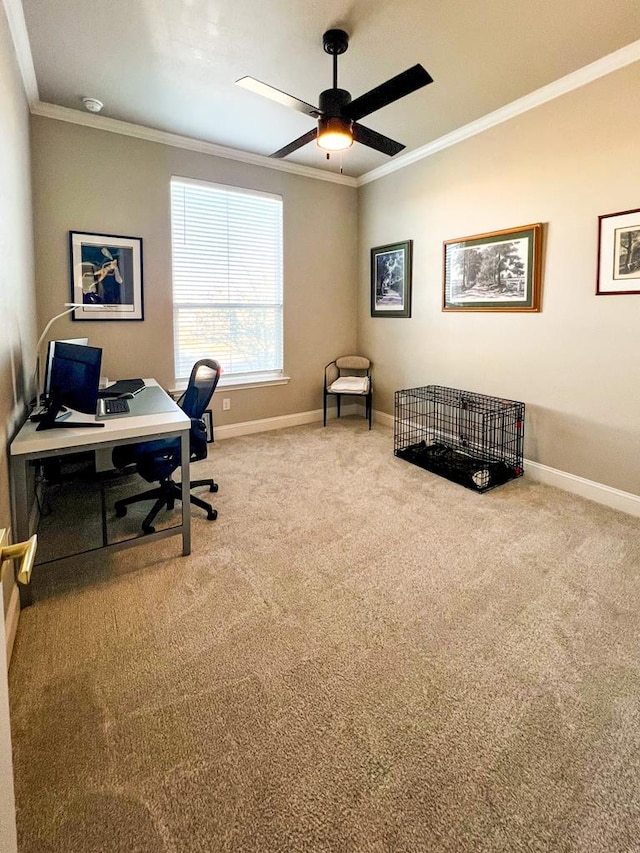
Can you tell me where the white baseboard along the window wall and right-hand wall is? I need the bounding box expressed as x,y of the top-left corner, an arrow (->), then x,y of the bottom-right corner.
216,404 -> 640,518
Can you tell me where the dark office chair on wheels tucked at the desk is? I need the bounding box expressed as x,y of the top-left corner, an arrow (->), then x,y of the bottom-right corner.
113,358 -> 222,533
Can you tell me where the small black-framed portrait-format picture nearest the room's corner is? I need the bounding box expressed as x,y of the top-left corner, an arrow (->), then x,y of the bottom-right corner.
371,240 -> 413,317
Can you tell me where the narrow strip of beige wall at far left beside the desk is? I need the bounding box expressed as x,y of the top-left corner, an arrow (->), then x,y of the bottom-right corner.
0,8 -> 36,609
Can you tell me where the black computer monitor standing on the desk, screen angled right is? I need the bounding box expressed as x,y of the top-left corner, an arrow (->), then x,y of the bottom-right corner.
49,342 -> 102,415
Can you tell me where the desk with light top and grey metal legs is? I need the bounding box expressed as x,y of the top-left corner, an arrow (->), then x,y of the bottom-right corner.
9,379 -> 191,607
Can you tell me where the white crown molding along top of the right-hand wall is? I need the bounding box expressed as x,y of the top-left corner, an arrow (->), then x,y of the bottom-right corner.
358,40 -> 640,187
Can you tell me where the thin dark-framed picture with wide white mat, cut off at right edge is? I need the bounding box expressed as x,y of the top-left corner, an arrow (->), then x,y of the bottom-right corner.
596,210 -> 640,296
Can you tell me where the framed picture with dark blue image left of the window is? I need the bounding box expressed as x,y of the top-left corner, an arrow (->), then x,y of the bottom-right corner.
69,231 -> 144,320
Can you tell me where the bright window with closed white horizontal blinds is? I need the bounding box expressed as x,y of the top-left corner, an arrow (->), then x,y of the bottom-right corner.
171,178 -> 283,381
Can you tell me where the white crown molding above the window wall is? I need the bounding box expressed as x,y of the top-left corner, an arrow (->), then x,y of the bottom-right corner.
31,101 -> 357,187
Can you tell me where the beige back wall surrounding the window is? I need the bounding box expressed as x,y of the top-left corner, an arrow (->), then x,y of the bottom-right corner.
32,117 -> 357,425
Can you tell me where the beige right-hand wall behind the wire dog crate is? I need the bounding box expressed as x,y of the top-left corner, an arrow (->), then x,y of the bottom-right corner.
358,63 -> 640,494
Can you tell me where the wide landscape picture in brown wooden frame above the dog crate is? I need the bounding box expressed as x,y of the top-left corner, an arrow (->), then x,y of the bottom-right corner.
442,223 -> 542,311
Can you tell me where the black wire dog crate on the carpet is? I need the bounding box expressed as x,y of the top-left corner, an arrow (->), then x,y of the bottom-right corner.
393,385 -> 524,492
